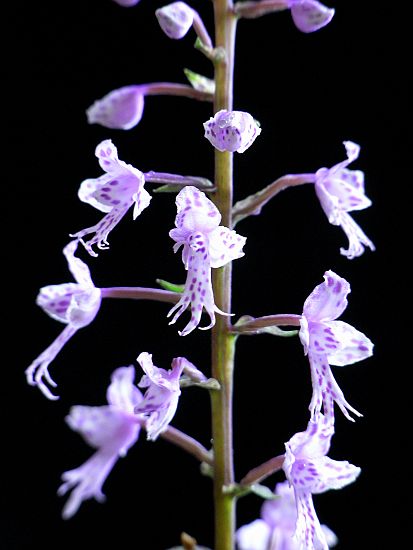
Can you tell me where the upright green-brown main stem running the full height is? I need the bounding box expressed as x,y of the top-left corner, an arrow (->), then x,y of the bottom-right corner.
211,0 -> 237,550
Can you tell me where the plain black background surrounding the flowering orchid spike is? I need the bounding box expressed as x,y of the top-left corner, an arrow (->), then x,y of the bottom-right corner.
4,0 -> 412,550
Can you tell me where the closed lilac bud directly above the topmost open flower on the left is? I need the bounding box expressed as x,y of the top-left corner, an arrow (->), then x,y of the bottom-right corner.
86,85 -> 145,130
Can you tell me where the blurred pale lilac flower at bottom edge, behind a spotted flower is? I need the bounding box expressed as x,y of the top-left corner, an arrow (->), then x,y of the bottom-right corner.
236,481 -> 337,550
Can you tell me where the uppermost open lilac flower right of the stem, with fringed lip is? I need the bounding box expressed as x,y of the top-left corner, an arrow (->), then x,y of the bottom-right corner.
315,141 -> 375,260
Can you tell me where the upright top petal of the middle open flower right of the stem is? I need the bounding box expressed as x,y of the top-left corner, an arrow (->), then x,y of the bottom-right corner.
303,270 -> 350,322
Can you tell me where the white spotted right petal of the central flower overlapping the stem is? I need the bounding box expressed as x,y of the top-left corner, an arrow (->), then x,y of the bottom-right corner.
209,225 -> 247,268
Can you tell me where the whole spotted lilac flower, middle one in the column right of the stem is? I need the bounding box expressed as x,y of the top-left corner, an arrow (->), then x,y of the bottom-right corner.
299,271 -> 373,420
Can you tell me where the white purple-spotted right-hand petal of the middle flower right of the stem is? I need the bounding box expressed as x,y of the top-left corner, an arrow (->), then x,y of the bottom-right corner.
328,321 -> 374,367
